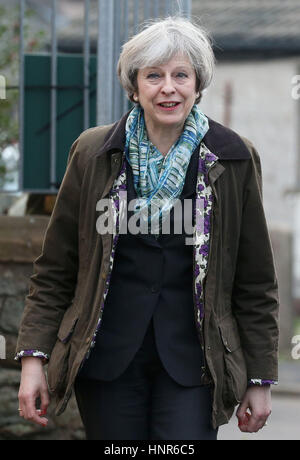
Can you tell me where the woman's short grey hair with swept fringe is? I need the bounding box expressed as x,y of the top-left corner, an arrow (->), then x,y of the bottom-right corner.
117,16 -> 215,103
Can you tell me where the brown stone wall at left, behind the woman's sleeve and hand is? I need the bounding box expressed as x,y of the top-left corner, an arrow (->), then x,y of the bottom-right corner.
0,216 -> 84,440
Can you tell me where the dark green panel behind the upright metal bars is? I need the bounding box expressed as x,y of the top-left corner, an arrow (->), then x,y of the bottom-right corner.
23,54 -> 97,193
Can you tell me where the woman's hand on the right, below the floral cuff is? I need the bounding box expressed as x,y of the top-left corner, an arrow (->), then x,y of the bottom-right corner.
236,385 -> 272,433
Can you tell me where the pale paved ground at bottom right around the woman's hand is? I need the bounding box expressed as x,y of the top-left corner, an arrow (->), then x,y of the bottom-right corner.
218,392 -> 300,441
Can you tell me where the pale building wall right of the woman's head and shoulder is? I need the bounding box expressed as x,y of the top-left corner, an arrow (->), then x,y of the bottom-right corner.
200,58 -> 300,297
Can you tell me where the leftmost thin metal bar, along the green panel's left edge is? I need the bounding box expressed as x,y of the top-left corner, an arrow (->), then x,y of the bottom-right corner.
18,0 -> 25,190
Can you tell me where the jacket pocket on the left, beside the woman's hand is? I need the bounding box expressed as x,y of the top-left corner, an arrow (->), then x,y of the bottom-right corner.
47,308 -> 78,395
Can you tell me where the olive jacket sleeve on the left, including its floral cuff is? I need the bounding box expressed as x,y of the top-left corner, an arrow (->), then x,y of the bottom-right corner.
16,138 -> 83,359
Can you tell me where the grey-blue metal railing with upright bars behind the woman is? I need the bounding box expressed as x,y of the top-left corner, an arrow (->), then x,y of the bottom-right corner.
19,0 -> 191,192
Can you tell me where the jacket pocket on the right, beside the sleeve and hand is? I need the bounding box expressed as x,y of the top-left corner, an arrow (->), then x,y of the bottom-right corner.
219,314 -> 247,407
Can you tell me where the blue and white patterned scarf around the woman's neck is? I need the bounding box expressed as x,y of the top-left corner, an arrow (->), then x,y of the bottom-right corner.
125,104 -> 209,233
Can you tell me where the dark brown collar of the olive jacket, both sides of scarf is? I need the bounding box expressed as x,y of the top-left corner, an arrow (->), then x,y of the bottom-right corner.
99,110 -> 251,160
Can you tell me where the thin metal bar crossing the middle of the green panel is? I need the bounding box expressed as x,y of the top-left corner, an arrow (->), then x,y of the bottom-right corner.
50,0 -> 57,190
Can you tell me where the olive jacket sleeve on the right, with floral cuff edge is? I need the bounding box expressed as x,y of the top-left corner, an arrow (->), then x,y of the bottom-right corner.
232,141 -> 279,383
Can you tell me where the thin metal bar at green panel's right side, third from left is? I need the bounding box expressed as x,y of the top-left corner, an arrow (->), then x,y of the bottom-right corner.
83,0 -> 90,129
